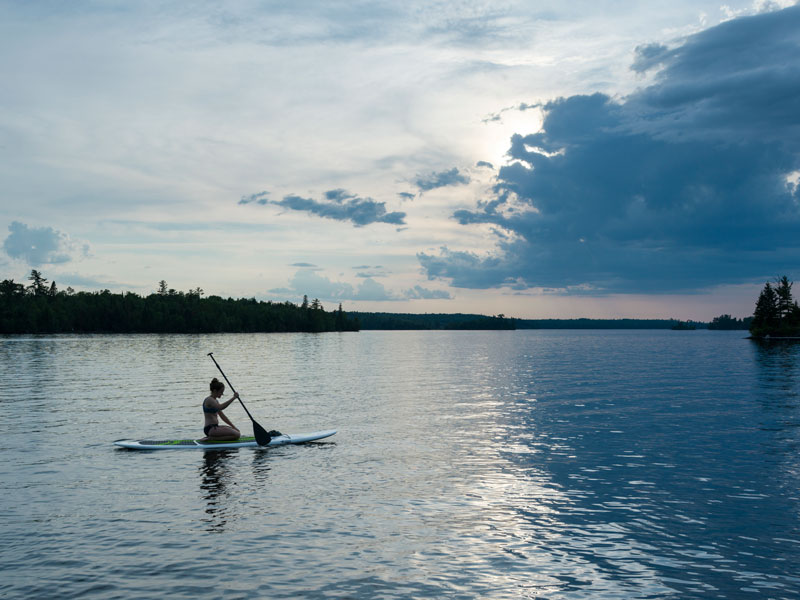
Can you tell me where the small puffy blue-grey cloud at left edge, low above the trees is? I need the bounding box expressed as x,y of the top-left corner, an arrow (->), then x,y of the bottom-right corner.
3,221 -> 89,267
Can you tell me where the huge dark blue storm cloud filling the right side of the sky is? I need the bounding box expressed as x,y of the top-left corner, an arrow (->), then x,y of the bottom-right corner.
418,6 -> 800,294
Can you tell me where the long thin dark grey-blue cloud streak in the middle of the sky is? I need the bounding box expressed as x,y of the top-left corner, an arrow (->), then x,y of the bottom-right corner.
252,189 -> 406,227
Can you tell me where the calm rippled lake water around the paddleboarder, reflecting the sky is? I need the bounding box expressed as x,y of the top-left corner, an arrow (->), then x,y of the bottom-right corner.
0,331 -> 800,600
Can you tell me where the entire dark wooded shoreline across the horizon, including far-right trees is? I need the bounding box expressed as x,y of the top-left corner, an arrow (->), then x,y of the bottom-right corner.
0,270 -> 800,338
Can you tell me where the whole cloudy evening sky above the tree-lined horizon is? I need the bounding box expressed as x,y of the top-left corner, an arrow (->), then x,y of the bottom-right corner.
0,0 -> 800,321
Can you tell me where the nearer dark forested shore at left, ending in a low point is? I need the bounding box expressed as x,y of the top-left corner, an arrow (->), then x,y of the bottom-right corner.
0,270 -> 359,333
